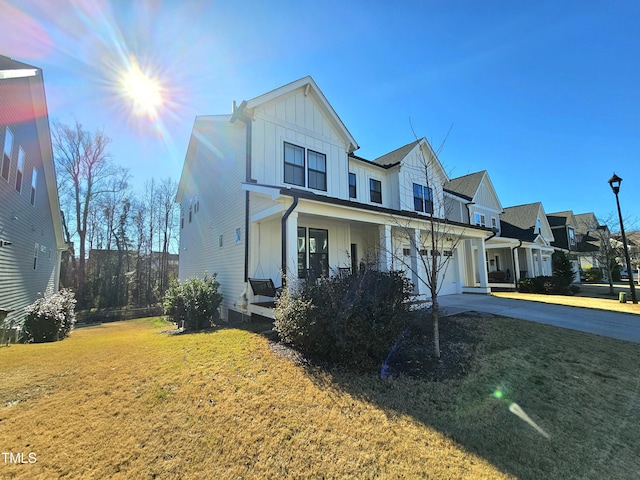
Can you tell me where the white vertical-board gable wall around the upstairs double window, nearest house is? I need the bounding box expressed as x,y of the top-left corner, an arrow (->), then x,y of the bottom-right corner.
251,89 -> 349,199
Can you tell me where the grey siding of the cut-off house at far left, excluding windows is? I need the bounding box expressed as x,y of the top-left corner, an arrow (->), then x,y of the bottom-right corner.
0,75 -> 60,328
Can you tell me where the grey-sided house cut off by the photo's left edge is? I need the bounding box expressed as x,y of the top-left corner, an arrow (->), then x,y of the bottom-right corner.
0,55 -> 66,330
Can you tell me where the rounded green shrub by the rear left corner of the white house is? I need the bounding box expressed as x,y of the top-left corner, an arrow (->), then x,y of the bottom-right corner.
164,273 -> 222,331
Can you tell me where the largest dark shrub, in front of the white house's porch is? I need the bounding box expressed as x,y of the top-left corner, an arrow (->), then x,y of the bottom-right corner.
274,270 -> 412,368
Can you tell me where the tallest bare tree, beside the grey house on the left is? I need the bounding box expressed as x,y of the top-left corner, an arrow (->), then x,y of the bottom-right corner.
52,120 -> 123,308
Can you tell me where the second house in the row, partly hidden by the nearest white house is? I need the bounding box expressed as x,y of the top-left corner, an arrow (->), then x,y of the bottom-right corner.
445,170 -> 520,289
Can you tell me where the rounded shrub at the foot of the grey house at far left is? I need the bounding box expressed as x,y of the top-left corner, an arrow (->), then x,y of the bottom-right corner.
23,288 -> 76,343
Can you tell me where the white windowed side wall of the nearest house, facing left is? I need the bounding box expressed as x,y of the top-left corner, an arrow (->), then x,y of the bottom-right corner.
178,116 -> 246,320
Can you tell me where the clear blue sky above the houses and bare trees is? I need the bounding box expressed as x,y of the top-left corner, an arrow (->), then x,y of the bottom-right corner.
0,0 -> 640,229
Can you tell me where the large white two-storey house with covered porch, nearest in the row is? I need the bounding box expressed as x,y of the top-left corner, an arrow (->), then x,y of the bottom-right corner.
176,77 -> 492,321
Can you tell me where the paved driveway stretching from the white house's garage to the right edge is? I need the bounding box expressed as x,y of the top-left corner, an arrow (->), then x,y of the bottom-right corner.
438,293 -> 640,343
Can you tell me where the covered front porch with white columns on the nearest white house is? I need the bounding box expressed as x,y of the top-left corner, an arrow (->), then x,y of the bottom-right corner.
248,188 -> 490,318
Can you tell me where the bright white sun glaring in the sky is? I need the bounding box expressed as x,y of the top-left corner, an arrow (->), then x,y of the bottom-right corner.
121,62 -> 164,119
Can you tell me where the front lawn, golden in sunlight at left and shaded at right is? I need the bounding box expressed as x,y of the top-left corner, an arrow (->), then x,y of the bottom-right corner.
0,316 -> 640,479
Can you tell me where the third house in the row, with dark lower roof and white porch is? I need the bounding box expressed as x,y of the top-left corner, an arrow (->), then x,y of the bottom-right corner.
500,202 -> 554,280
